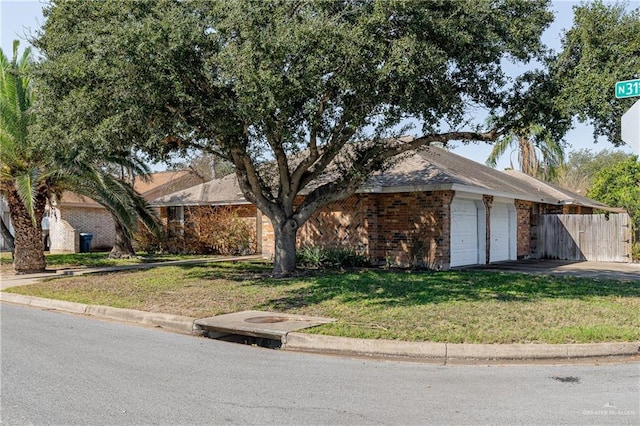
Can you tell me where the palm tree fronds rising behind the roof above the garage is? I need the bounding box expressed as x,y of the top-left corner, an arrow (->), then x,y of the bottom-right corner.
486,125 -> 564,180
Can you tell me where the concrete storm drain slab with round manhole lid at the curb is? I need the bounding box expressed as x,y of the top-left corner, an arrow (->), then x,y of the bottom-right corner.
196,311 -> 335,340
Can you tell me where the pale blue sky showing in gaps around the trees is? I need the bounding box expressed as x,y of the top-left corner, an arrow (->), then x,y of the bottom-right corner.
0,0 -> 640,169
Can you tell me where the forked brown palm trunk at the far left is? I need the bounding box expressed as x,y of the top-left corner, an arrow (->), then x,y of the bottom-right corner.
7,191 -> 47,274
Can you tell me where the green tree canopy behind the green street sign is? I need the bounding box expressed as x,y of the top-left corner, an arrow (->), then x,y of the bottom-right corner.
551,1 -> 640,146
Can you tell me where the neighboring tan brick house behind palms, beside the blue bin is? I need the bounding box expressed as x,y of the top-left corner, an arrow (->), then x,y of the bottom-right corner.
49,170 -> 202,253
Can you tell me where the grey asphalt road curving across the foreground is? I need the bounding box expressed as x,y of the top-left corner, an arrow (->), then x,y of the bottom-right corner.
0,303 -> 640,425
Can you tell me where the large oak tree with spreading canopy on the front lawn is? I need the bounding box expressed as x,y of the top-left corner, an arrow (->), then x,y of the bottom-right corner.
36,0 -> 553,275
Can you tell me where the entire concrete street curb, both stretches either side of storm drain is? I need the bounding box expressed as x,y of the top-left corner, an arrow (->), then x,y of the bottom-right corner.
5,292 -> 640,364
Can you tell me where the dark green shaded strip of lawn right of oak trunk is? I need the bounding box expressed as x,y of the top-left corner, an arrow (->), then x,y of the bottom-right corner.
256,271 -> 640,309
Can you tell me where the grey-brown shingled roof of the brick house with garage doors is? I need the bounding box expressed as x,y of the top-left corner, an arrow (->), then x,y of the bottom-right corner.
151,146 -> 623,211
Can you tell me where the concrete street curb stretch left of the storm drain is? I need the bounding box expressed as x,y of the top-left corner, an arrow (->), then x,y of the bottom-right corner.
0,292 -> 198,334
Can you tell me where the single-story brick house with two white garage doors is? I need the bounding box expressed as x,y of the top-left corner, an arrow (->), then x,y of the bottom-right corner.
152,147 -> 623,269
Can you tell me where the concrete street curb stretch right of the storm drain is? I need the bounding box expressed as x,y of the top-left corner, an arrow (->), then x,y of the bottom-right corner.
282,332 -> 640,364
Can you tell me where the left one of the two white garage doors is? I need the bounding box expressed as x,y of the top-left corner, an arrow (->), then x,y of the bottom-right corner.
450,199 -> 478,266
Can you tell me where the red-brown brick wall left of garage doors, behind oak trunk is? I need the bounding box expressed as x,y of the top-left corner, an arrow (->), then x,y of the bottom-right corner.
262,191 -> 454,269
